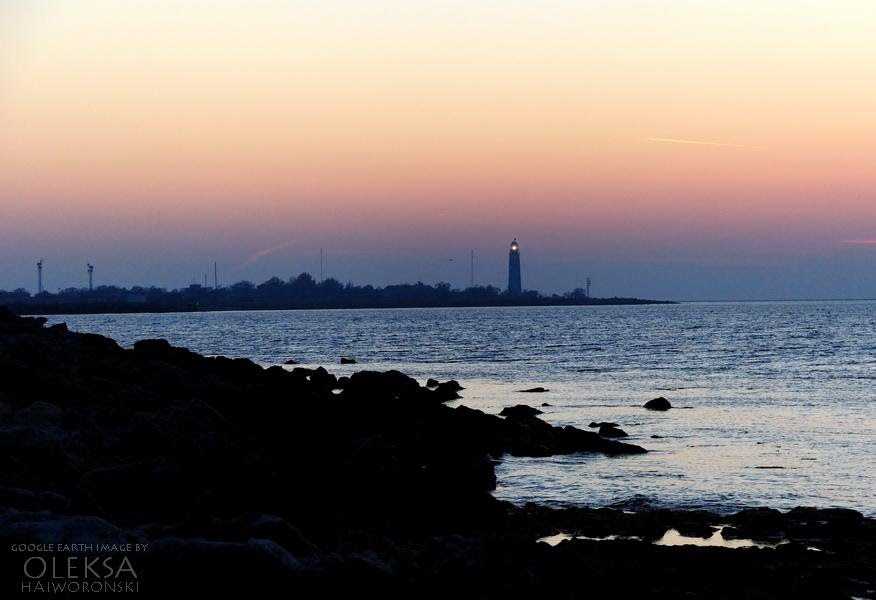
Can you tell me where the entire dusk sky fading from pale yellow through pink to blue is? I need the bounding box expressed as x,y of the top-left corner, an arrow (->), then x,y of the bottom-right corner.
0,0 -> 876,300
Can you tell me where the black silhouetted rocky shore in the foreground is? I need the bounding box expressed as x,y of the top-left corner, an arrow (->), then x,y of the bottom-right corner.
0,309 -> 876,598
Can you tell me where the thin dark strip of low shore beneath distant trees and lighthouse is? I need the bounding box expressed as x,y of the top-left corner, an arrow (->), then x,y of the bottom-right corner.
9,298 -> 678,315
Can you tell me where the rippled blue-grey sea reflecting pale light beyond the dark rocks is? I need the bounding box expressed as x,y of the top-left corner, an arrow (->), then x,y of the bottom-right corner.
51,302 -> 876,515
